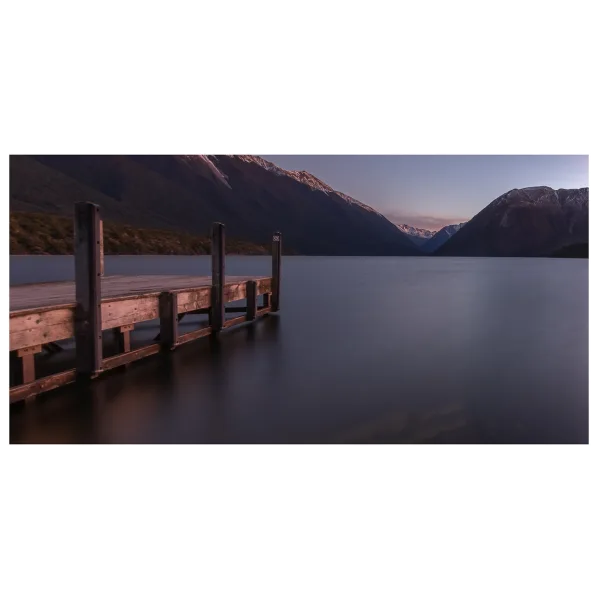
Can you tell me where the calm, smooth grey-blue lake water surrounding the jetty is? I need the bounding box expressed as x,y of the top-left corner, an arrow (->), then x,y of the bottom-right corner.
10,256 -> 589,444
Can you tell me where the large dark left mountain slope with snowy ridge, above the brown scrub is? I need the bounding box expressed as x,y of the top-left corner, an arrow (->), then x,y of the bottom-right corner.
11,155 -> 420,255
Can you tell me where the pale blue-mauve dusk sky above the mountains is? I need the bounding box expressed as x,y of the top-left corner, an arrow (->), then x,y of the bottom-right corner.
262,154 -> 589,229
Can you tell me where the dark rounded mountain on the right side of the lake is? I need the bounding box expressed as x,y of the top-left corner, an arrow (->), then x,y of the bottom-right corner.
436,187 -> 589,256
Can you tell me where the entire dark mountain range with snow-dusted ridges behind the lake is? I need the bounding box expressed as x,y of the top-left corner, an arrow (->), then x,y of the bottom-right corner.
10,155 -> 589,256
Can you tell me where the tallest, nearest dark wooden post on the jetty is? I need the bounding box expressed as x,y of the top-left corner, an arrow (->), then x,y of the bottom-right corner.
74,202 -> 102,378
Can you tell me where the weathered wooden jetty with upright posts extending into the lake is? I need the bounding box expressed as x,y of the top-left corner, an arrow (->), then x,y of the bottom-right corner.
9,202 -> 282,403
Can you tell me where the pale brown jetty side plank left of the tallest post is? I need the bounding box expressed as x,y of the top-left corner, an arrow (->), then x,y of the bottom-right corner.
9,308 -> 75,350
